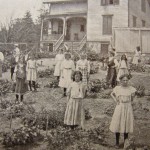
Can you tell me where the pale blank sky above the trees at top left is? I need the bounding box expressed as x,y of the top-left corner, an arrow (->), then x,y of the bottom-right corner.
0,0 -> 42,24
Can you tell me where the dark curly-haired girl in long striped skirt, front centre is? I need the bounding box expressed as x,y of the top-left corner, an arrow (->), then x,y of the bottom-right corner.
64,71 -> 85,129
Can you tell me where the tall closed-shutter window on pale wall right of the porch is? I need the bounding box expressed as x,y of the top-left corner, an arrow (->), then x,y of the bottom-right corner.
103,15 -> 112,35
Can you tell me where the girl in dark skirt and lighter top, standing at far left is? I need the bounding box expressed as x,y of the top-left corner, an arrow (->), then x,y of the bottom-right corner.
15,56 -> 27,102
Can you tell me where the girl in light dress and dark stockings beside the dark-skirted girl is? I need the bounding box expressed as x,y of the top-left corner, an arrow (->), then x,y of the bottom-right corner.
27,54 -> 37,91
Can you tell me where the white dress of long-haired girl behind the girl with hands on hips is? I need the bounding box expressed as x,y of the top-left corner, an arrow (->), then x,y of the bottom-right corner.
117,60 -> 129,81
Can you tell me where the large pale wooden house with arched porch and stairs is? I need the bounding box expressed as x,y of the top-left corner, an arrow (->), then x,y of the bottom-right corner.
41,0 -> 150,55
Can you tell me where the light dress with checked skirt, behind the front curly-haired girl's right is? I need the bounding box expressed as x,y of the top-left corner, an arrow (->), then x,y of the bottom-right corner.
76,59 -> 90,84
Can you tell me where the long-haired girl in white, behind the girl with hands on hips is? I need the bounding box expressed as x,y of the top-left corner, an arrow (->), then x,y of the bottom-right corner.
117,54 -> 129,82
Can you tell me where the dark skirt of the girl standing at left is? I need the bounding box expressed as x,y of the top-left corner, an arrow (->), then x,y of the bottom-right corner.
15,78 -> 28,95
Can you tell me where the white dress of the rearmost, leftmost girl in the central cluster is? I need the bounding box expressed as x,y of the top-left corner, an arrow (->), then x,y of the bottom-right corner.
54,54 -> 64,76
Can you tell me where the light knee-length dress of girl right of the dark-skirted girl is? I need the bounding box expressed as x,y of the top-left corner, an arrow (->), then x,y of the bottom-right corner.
26,60 -> 37,81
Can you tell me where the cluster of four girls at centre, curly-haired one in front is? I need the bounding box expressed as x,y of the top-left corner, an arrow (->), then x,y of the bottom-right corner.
54,49 -> 90,128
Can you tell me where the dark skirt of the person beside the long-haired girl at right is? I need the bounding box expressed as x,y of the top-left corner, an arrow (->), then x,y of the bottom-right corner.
106,67 -> 117,87
